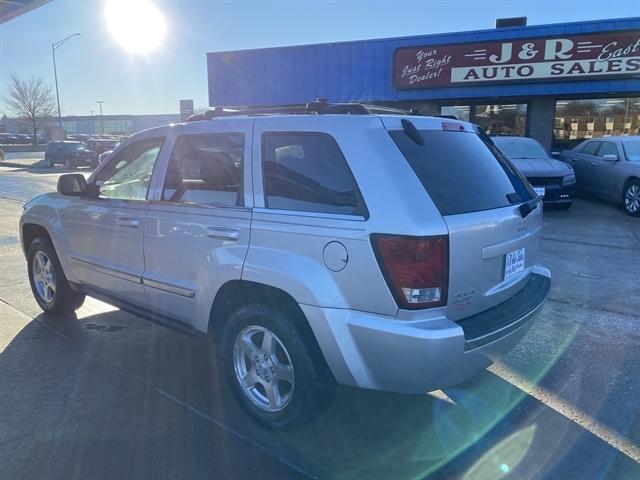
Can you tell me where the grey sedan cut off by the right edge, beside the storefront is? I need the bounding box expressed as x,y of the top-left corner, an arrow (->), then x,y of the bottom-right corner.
560,136 -> 640,217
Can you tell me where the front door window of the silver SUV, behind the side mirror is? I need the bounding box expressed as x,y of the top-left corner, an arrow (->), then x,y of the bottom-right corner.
95,138 -> 164,200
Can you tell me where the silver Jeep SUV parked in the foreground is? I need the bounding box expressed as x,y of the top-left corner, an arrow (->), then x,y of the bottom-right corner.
20,104 -> 550,428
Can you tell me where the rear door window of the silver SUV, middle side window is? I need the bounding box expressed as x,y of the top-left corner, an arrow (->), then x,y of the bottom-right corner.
162,133 -> 244,207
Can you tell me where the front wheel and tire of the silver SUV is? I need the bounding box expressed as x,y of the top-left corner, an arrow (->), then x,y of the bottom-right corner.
27,237 -> 85,315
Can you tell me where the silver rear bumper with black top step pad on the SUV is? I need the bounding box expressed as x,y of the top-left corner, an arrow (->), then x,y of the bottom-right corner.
301,267 -> 551,393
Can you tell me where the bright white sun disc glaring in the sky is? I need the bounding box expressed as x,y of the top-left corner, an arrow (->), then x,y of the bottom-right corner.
105,0 -> 166,54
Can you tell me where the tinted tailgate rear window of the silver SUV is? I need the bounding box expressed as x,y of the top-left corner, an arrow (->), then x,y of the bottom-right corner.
389,130 -> 533,215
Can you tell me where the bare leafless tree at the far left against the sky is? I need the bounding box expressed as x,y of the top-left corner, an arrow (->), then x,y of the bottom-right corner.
4,74 -> 56,145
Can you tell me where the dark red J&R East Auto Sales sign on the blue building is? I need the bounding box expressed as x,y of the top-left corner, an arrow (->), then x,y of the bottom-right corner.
394,30 -> 640,89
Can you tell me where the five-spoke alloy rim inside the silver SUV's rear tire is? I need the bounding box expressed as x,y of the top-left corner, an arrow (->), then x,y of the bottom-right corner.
233,325 -> 295,413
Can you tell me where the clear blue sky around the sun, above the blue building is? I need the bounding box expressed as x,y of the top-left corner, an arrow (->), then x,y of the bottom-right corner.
0,0 -> 640,115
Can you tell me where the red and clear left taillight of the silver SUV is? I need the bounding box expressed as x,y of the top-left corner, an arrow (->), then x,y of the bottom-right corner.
371,234 -> 449,310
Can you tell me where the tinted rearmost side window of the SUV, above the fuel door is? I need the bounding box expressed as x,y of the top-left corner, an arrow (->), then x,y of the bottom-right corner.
262,132 -> 366,215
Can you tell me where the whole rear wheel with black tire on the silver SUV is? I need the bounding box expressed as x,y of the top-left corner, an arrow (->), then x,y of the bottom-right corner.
216,304 -> 335,430
